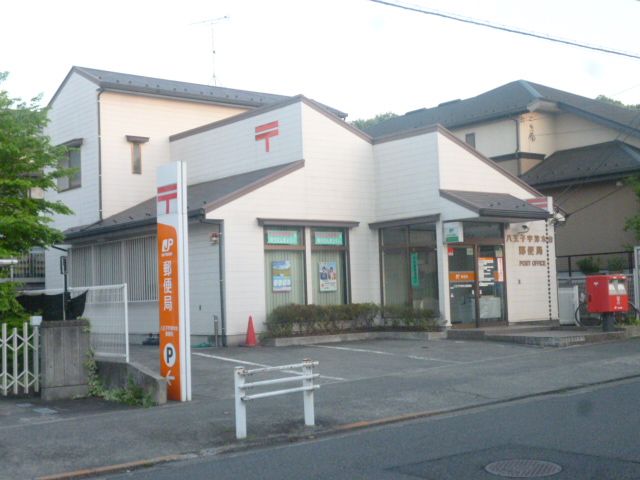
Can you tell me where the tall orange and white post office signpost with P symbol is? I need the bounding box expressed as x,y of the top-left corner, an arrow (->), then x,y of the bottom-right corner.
157,162 -> 191,402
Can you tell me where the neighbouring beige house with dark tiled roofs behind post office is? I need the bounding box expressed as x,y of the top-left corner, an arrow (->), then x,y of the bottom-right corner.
367,80 -> 640,273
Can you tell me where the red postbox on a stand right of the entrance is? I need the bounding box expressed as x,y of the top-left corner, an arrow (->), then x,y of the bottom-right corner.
587,275 -> 629,332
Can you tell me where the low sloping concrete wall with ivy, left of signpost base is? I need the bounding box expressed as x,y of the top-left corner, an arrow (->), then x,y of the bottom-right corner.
96,359 -> 167,405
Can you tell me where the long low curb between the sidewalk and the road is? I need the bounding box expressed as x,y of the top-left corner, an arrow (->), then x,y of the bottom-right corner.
36,374 -> 640,480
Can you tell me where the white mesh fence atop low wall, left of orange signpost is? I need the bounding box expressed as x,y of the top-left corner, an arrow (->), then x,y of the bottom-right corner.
23,283 -> 129,363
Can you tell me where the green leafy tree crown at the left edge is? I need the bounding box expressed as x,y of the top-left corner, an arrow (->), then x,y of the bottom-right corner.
0,72 -> 71,258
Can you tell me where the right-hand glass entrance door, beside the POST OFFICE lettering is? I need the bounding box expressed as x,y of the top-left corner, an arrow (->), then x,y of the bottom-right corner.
478,245 -> 505,323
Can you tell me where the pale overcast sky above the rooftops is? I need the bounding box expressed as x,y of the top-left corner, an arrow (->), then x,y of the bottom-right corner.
0,0 -> 640,120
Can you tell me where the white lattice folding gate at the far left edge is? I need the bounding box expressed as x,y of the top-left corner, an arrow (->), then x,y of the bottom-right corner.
0,323 -> 40,396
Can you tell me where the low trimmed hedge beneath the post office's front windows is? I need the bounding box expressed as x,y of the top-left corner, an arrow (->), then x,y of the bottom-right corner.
266,303 -> 437,337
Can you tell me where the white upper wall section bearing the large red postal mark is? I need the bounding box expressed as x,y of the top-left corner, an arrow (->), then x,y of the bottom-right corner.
171,103 -> 303,185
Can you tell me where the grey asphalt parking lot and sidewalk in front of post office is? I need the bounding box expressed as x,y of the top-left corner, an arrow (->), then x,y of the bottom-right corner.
0,340 -> 640,478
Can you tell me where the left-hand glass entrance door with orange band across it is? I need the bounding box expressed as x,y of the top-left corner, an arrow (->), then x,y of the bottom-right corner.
448,245 -> 476,326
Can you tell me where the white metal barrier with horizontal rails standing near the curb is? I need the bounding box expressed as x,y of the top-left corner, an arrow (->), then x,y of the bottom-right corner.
234,358 -> 320,440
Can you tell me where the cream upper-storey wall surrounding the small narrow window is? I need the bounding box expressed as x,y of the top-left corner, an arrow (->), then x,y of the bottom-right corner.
100,92 -> 245,217
